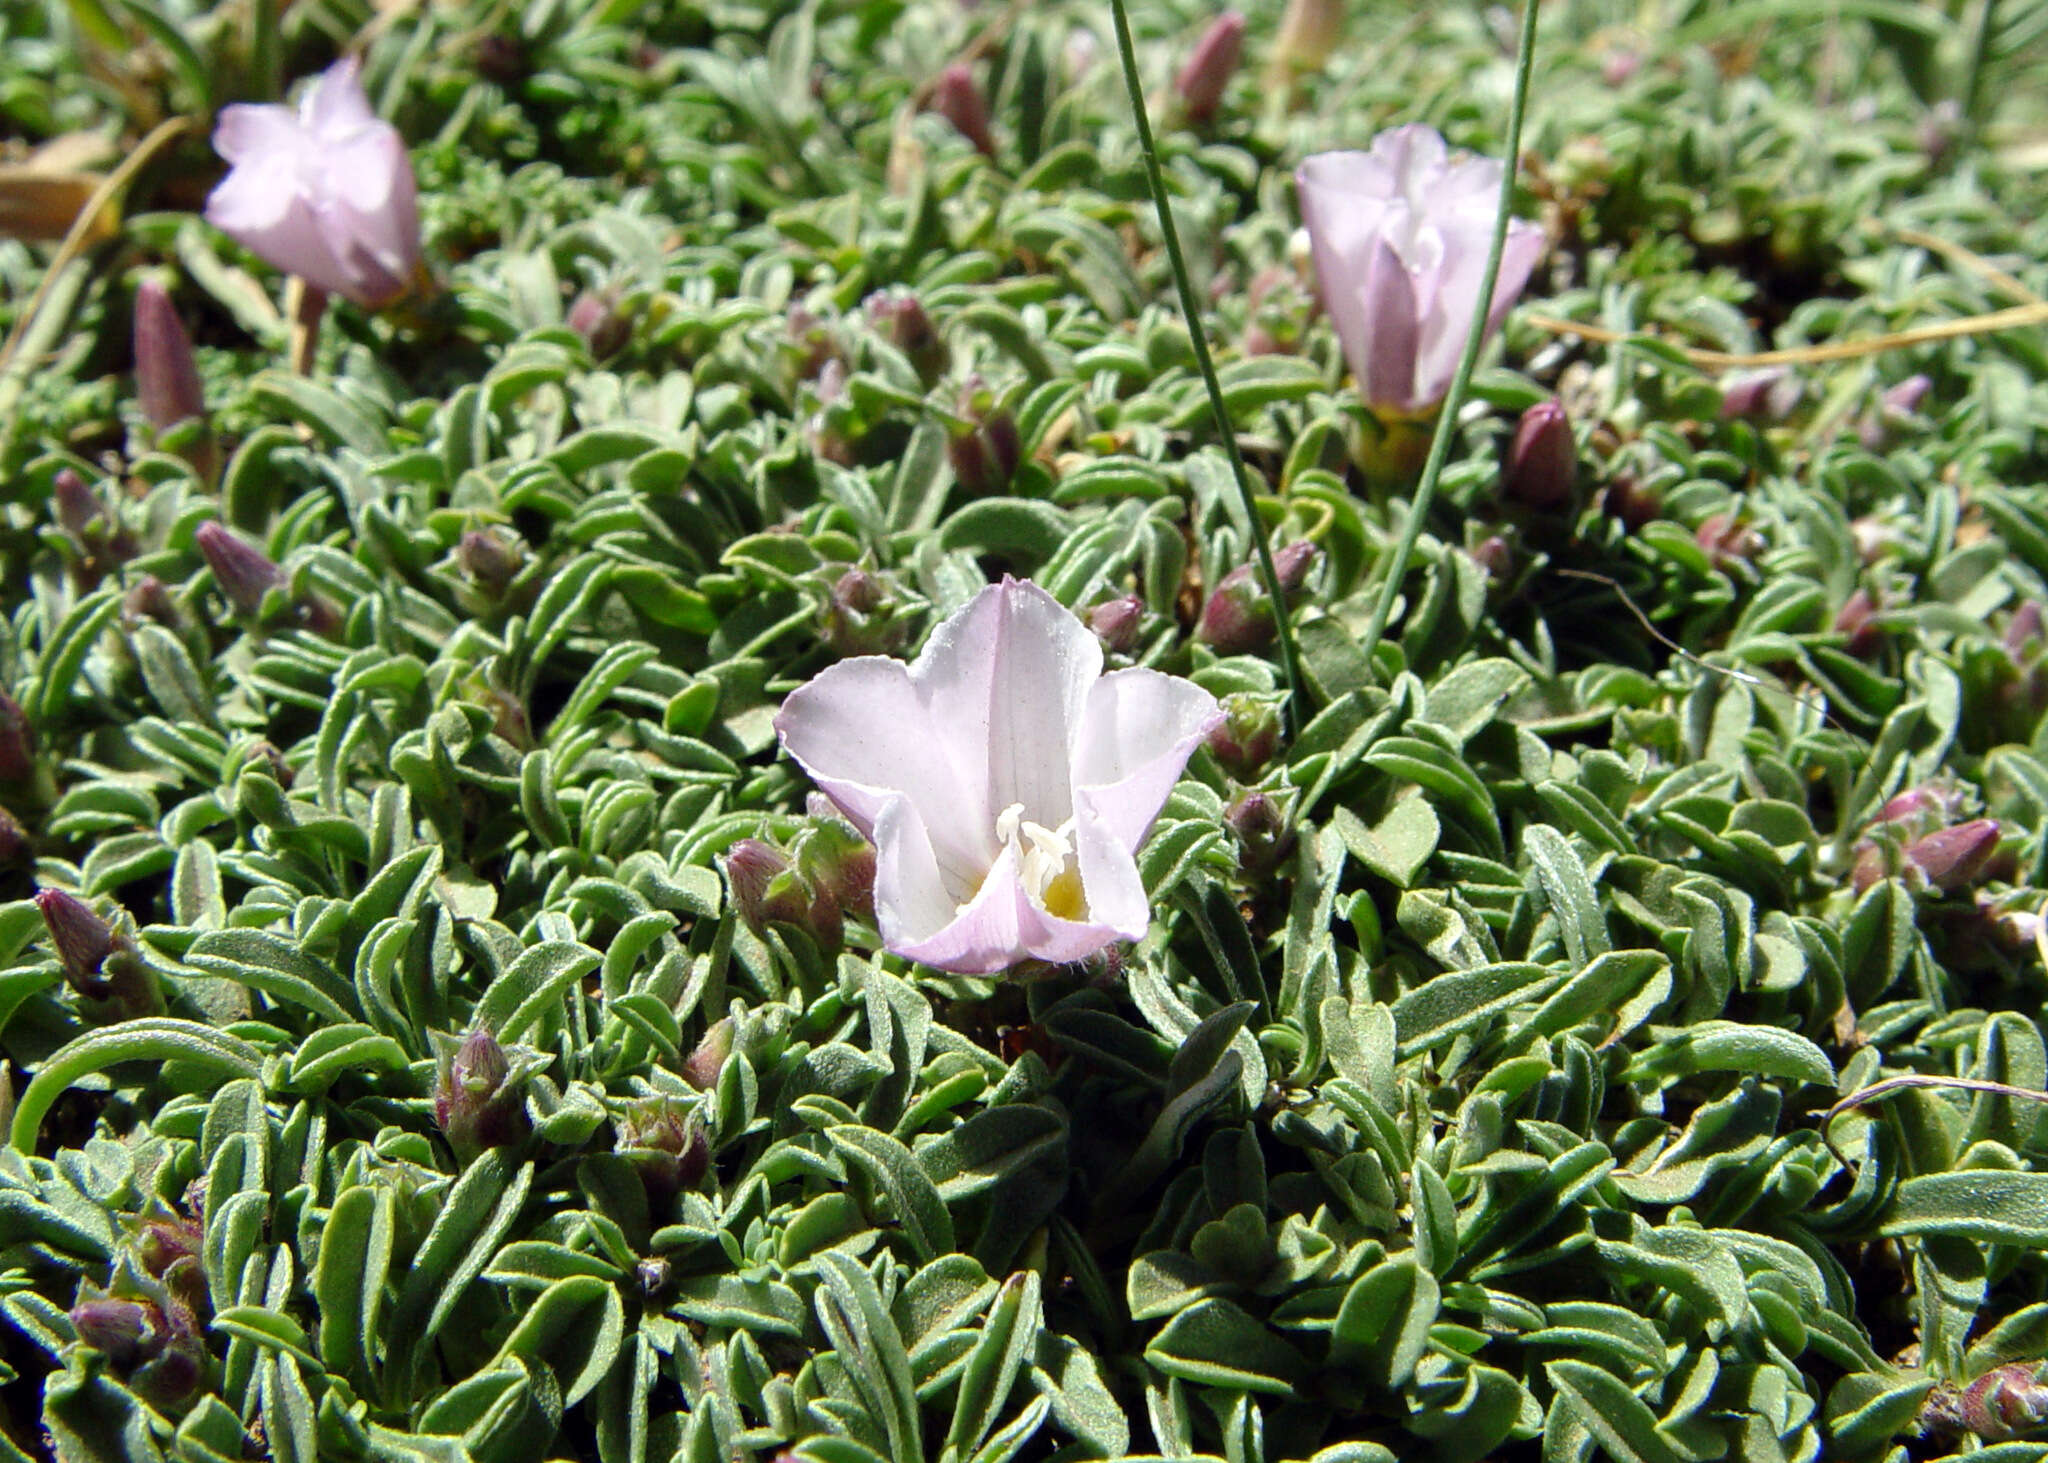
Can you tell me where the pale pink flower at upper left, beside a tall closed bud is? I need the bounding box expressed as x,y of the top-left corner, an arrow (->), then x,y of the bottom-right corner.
207,57 -> 420,309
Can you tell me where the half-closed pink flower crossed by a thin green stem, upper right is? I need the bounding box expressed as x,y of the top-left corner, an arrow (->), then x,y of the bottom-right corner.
1294,127 -> 1544,414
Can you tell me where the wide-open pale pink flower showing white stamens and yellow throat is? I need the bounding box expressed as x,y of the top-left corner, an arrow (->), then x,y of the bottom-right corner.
776,578 -> 1221,973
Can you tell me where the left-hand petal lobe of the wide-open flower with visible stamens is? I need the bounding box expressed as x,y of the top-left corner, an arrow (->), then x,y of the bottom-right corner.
774,656 -> 997,897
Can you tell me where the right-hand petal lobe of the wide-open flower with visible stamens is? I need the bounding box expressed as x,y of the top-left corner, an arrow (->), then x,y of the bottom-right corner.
1073,666 -> 1223,848
